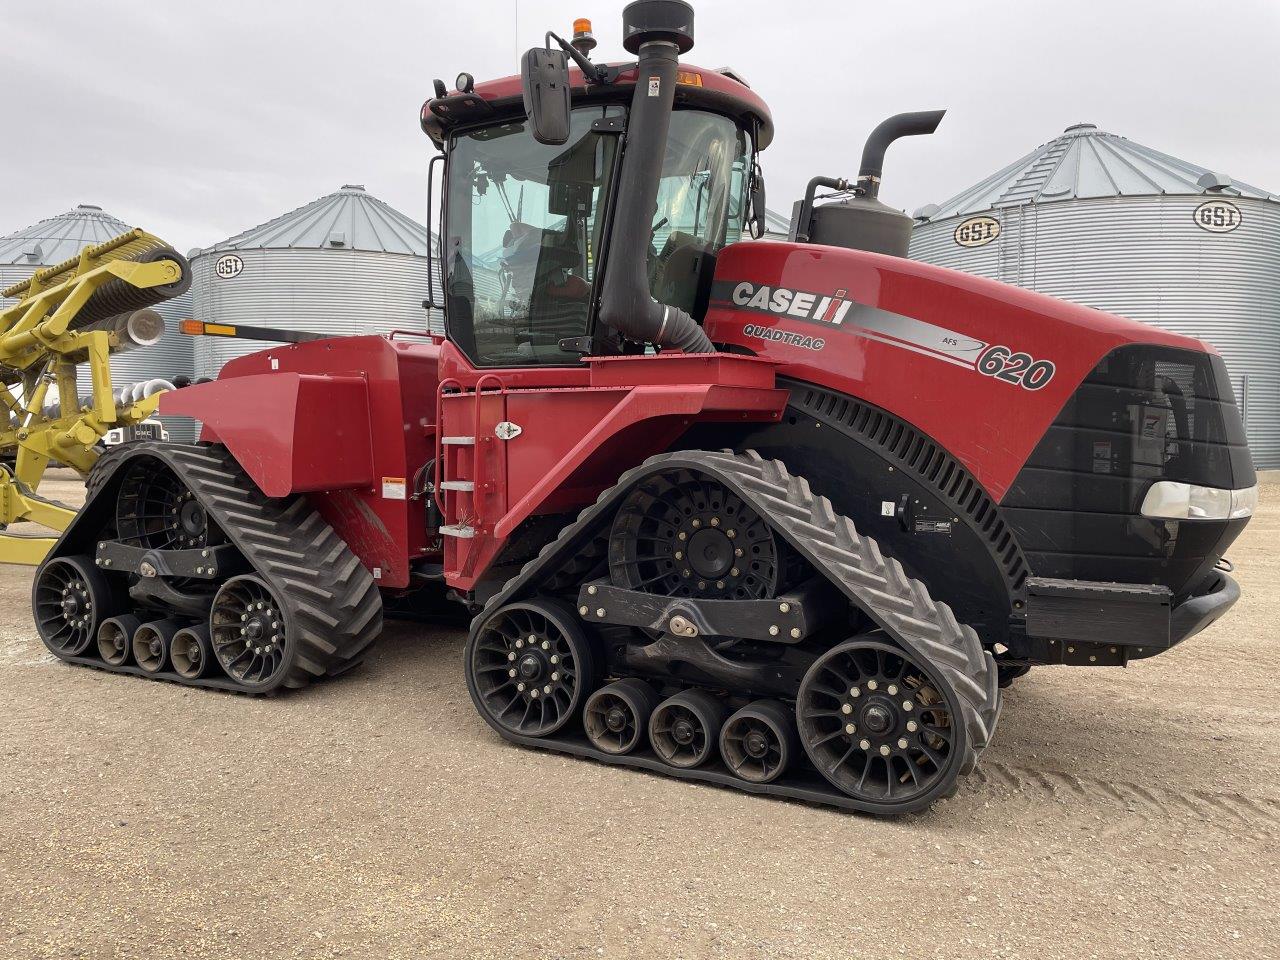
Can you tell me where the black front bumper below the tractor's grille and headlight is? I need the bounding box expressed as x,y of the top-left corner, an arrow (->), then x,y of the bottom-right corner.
1025,571 -> 1240,666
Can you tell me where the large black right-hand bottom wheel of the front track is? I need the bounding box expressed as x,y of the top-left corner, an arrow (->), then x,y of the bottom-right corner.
796,637 -> 966,814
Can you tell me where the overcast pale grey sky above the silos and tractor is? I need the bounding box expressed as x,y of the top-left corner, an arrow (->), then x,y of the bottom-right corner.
0,0 -> 1280,250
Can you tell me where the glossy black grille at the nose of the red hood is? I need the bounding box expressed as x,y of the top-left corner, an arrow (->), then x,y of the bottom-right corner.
1002,344 -> 1256,594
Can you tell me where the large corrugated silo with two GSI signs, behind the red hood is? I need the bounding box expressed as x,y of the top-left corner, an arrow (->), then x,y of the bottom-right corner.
911,123 -> 1280,467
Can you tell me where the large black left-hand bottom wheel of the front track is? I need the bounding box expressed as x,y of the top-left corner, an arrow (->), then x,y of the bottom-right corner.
466,599 -> 596,737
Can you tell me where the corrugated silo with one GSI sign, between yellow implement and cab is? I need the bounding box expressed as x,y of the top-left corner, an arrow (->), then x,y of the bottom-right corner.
192,184 -> 440,376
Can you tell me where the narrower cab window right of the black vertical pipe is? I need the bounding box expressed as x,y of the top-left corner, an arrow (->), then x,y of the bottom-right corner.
649,110 -> 750,317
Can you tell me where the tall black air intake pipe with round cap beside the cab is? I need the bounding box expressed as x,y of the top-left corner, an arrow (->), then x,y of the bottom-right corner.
600,0 -> 716,353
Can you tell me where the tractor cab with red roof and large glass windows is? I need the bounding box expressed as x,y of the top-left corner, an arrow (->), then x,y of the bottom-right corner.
422,5 -> 772,367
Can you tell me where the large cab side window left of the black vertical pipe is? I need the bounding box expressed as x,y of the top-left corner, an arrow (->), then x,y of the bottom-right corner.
445,106 -> 622,366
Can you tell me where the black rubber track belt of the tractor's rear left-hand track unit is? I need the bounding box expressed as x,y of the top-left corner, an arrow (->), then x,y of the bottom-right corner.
37,442 -> 383,692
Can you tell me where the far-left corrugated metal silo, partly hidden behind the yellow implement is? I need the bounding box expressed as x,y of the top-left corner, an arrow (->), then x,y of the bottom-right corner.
0,204 -> 195,442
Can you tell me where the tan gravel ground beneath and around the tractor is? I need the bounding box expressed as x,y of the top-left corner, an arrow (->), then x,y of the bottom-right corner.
0,471 -> 1280,960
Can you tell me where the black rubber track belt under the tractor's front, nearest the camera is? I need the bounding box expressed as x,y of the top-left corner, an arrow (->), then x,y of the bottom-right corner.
476,451 -> 1001,813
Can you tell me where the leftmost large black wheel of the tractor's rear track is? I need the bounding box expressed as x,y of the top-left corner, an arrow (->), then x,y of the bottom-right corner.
31,556 -> 116,658
